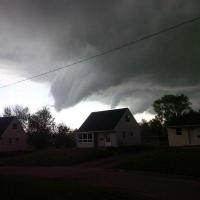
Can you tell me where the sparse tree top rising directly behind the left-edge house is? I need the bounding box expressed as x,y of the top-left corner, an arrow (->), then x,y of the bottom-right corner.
3,105 -> 30,130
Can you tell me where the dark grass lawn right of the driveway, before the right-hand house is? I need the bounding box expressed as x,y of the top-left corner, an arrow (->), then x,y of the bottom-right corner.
114,148 -> 200,178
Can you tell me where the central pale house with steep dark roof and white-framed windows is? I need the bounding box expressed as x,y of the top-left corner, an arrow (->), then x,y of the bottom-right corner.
76,108 -> 141,148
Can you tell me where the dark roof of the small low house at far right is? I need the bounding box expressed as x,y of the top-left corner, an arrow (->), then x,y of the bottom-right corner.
167,112 -> 200,127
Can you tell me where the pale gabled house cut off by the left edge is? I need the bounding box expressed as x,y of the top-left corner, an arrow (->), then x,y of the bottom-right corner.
0,117 -> 27,152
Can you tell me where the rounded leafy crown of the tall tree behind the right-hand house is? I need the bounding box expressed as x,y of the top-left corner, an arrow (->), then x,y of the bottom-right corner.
153,94 -> 192,123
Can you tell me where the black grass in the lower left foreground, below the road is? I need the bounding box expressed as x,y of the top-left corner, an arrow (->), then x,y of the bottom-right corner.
0,176 -> 136,200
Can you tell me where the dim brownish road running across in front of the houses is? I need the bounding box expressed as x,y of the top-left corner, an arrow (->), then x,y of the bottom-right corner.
0,166 -> 200,200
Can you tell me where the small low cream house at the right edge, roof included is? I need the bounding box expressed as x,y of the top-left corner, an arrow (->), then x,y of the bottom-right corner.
167,115 -> 200,147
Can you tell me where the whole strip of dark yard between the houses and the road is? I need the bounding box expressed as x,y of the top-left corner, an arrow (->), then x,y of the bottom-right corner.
0,147 -> 200,179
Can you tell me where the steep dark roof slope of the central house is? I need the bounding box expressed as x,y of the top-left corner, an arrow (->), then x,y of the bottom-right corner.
78,108 -> 128,132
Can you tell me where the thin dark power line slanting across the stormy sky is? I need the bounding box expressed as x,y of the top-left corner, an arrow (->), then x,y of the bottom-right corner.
0,16 -> 200,89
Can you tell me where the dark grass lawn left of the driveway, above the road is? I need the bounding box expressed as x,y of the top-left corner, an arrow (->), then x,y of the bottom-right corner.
0,149 -> 116,166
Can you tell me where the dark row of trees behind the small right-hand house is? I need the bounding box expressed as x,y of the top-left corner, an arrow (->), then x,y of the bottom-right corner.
140,94 -> 200,144
